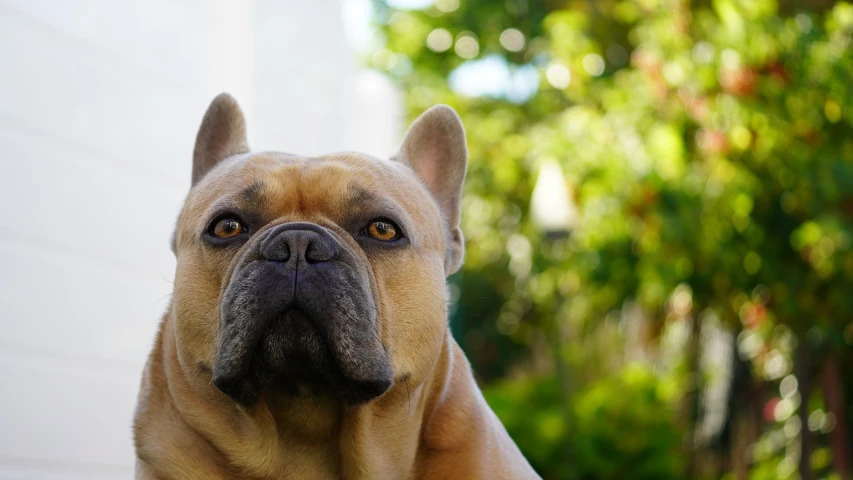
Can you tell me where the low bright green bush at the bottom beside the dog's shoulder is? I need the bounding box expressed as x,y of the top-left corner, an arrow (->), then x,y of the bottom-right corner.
486,365 -> 684,480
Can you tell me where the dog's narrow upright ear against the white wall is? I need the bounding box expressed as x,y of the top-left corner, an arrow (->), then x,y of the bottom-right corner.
193,93 -> 249,185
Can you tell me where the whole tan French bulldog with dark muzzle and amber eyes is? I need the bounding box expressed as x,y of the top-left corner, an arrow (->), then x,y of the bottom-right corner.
134,94 -> 538,480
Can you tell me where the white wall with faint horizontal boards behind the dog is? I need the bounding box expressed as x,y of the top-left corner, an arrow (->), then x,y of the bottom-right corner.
0,0 -> 400,479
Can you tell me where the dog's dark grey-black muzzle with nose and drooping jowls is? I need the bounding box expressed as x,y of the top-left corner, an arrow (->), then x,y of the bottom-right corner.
208,224 -> 393,405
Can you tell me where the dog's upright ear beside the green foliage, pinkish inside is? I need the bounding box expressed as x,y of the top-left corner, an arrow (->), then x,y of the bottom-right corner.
395,105 -> 468,275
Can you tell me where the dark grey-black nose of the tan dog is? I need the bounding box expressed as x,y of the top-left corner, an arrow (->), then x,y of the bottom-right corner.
261,222 -> 338,268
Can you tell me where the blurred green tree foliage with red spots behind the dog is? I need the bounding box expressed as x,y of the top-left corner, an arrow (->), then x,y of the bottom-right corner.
368,0 -> 853,479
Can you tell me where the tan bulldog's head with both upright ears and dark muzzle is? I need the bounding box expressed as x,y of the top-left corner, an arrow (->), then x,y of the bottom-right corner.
172,95 -> 466,405
